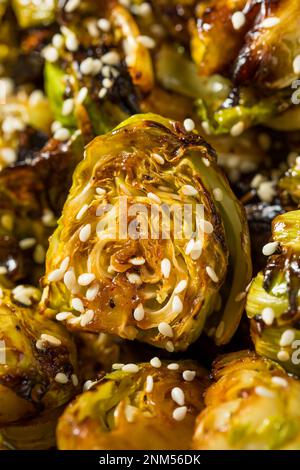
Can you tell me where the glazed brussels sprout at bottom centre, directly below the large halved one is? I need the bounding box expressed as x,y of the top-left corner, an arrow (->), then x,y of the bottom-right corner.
57,358 -> 208,450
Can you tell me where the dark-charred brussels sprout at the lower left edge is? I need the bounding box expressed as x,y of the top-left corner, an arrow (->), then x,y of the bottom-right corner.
0,285 -> 77,426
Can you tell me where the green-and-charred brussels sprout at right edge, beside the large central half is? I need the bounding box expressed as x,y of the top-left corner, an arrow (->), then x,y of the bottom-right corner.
246,211 -> 300,375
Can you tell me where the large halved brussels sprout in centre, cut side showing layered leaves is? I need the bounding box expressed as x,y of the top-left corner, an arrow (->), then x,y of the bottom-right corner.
41,114 -> 251,351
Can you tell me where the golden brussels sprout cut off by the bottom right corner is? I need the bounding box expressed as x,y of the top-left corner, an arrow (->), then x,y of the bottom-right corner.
193,352 -> 300,450
